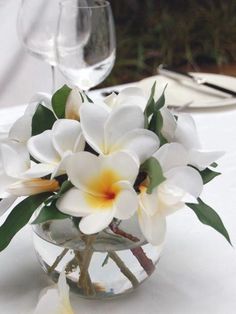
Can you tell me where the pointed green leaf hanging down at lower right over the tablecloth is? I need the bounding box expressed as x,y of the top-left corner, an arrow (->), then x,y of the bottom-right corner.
186,198 -> 232,245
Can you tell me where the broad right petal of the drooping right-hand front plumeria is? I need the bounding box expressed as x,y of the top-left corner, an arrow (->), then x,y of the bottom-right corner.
165,166 -> 203,198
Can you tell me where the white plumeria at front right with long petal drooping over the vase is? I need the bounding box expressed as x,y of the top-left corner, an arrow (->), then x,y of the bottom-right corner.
138,143 -> 203,245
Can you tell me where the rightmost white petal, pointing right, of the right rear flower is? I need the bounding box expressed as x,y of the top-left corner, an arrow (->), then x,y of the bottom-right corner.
189,149 -> 224,170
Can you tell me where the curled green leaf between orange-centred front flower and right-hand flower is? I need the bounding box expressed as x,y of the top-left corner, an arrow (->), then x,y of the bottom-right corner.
140,157 -> 166,194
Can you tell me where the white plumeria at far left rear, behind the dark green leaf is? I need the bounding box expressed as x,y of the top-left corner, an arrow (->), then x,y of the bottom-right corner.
8,93 -> 52,143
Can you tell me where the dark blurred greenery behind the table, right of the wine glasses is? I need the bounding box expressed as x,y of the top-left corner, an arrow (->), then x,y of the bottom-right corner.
100,0 -> 236,87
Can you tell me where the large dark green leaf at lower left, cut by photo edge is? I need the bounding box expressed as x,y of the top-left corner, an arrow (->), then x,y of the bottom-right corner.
0,193 -> 51,252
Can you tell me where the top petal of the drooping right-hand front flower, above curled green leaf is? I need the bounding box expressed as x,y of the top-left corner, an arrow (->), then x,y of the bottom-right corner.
153,143 -> 188,172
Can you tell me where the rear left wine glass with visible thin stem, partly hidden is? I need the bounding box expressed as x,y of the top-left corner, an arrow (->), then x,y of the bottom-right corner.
17,0 -> 60,91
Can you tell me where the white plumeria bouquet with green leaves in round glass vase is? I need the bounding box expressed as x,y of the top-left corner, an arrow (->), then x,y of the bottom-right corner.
0,84 -> 230,298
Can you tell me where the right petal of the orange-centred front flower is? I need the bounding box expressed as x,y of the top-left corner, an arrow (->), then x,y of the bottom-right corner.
114,181 -> 138,219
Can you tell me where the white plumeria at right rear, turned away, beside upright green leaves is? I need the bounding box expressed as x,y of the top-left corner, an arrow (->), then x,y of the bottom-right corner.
161,108 -> 224,170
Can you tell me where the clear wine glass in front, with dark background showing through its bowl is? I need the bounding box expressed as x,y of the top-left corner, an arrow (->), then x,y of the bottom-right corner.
56,0 -> 116,90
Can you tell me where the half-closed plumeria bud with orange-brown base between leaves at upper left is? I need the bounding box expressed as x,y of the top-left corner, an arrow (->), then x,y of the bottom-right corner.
65,87 -> 88,121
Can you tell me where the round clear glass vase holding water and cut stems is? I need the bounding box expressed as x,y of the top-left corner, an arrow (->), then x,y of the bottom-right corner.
33,217 -> 163,299
